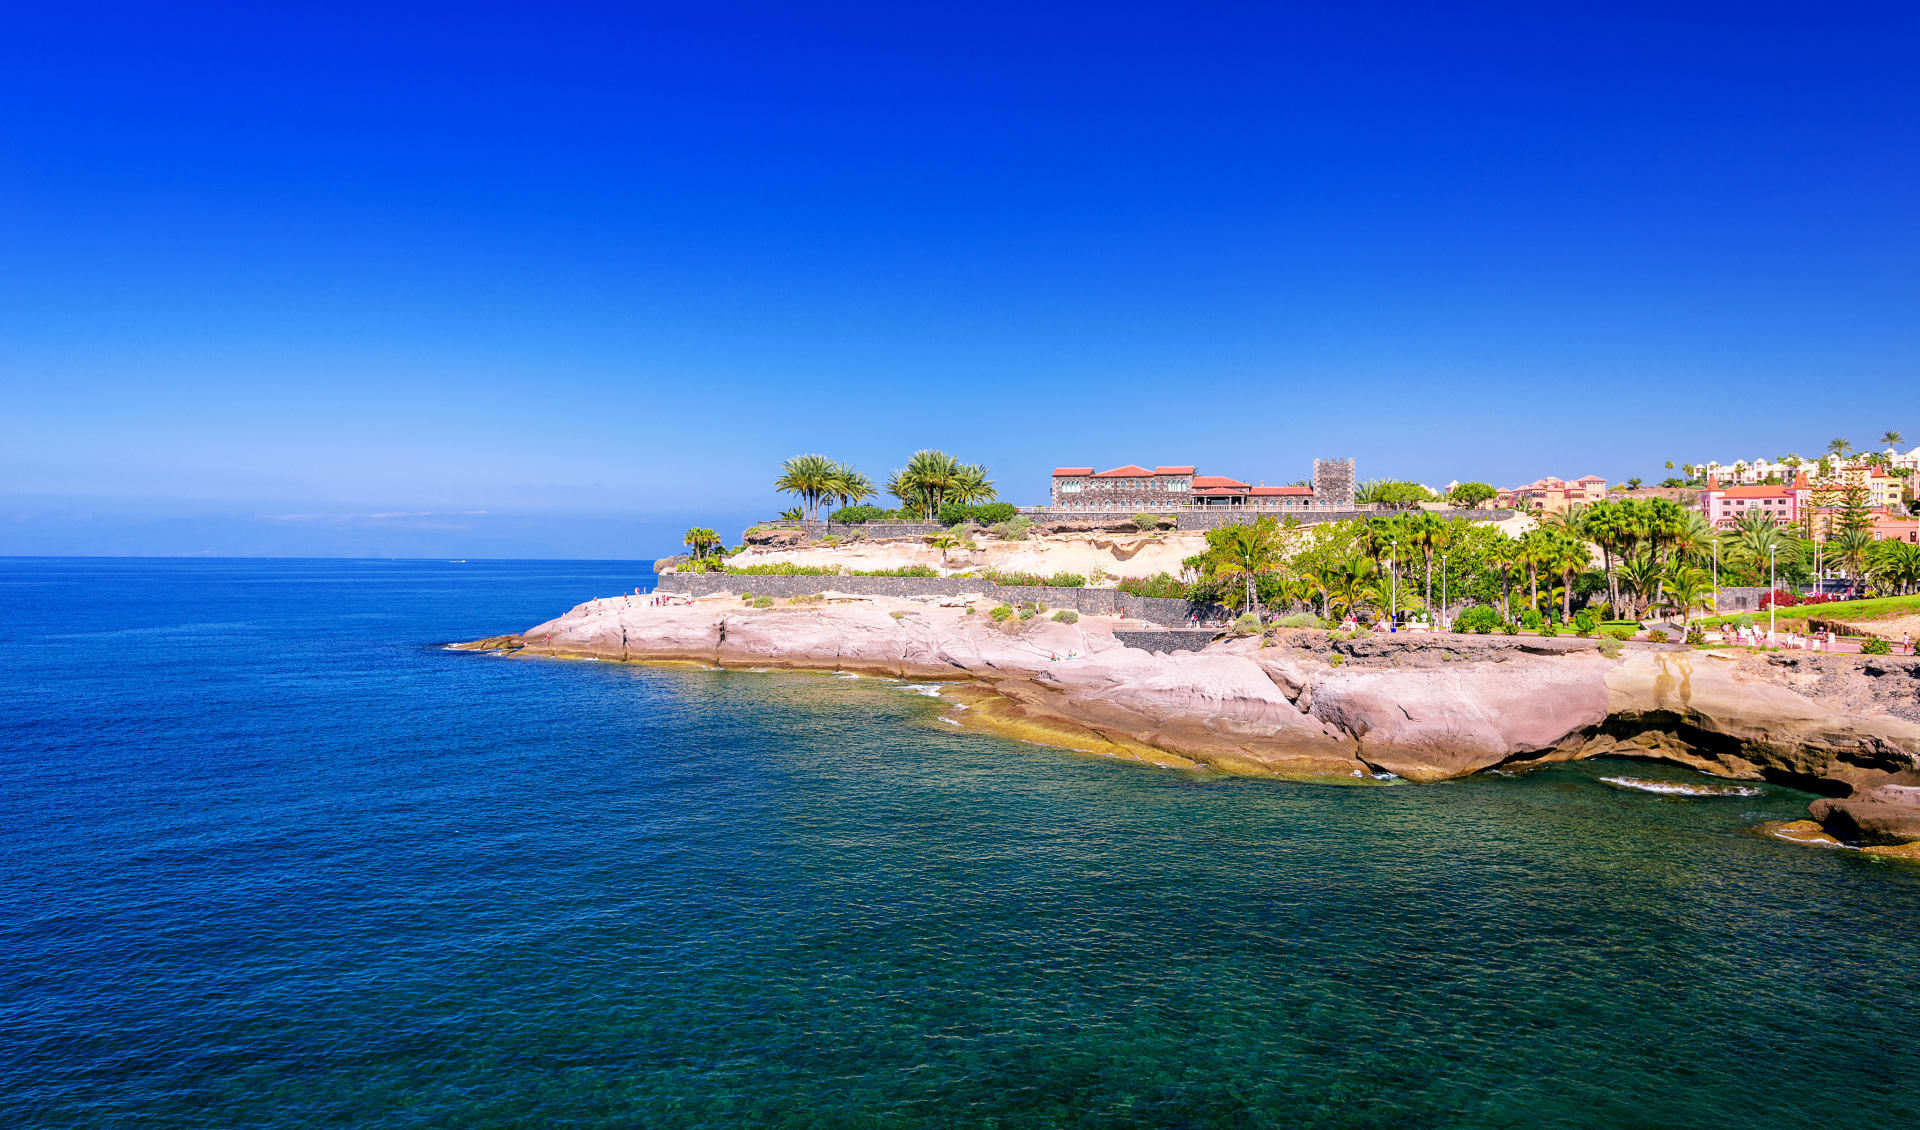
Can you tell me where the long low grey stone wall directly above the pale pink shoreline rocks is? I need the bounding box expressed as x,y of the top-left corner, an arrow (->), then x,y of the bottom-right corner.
660,574 -> 1223,627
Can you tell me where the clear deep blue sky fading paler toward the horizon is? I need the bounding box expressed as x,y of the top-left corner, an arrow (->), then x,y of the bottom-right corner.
0,2 -> 1920,556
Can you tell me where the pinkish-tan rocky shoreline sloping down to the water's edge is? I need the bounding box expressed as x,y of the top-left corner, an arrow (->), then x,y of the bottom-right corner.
449,593 -> 1920,859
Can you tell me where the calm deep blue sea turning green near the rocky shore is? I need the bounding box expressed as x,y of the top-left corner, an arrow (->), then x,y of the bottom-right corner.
0,558 -> 1920,1128
